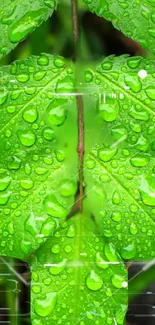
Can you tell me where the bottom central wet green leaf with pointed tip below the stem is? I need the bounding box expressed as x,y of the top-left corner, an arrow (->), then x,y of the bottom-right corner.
31,215 -> 127,325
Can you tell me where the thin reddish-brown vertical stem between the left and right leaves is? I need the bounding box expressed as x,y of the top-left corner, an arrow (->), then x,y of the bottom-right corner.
71,0 -> 84,212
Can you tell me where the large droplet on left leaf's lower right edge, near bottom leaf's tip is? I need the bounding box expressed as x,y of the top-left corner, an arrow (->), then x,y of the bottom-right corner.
44,194 -> 66,218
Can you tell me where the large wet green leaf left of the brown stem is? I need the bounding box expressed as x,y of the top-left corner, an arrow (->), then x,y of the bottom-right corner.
0,55 -> 78,259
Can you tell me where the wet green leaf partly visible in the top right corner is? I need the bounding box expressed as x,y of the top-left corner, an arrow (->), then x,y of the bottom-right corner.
84,0 -> 155,53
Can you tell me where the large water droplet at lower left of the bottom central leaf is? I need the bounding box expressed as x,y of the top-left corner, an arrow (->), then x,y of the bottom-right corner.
34,292 -> 57,317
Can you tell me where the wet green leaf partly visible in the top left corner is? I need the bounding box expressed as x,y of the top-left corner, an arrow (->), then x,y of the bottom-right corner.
0,0 -> 58,58
